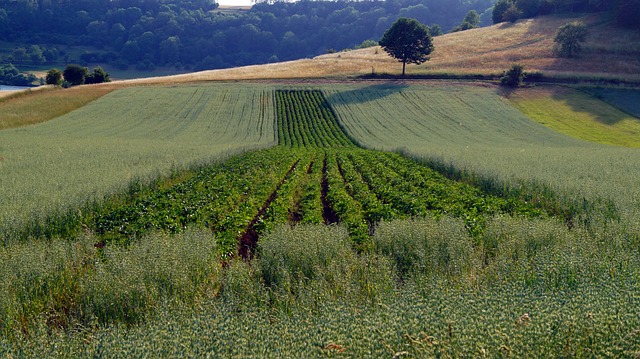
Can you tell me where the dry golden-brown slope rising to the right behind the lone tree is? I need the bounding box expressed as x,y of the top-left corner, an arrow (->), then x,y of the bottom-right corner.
115,14 -> 640,84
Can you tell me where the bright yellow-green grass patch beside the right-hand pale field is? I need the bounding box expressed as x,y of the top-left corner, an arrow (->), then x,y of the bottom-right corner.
509,87 -> 640,147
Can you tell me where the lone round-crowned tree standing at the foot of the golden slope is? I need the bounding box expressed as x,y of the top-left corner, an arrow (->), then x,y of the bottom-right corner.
380,17 -> 433,76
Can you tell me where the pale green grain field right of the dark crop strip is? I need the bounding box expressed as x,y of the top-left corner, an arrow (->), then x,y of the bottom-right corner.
325,85 -> 640,215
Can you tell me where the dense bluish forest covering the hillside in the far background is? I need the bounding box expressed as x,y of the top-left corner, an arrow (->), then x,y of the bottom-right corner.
0,0 -> 640,75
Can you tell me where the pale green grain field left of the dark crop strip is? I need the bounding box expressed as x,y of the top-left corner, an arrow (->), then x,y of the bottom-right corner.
0,85 -> 275,232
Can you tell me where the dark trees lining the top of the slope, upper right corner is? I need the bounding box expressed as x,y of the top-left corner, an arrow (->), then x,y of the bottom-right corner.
491,0 -> 640,29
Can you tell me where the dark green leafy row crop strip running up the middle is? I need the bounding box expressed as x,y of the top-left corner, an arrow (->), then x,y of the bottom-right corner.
61,90 -> 541,256
